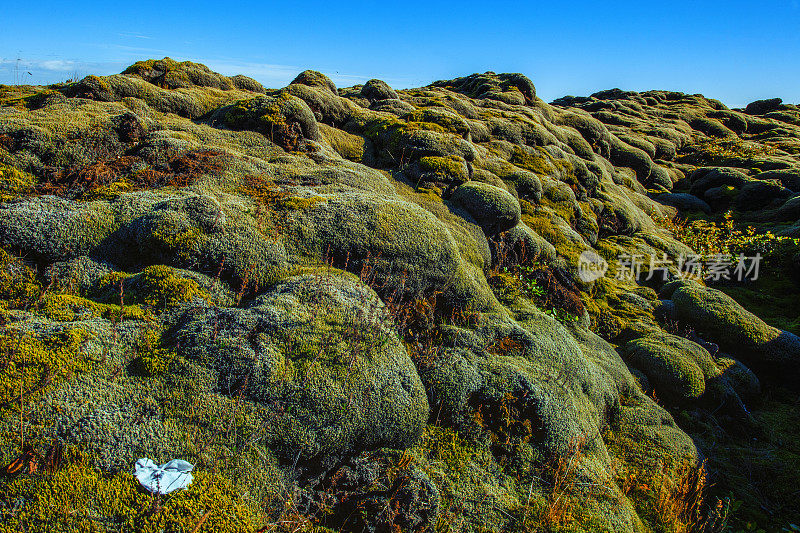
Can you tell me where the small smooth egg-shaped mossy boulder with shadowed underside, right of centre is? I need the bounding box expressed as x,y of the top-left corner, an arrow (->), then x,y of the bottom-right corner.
450,182 -> 522,235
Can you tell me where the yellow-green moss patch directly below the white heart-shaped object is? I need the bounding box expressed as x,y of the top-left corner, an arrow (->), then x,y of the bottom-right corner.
0,463 -> 262,533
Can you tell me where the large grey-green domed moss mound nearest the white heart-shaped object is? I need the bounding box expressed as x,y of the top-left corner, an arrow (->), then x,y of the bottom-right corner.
175,274 -> 428,460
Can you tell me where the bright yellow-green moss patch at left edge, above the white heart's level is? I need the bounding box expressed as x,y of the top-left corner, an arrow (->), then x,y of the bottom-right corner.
0,329 -> 92,409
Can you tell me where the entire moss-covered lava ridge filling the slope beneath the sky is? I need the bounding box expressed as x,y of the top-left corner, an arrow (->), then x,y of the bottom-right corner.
0,58 -> 800,531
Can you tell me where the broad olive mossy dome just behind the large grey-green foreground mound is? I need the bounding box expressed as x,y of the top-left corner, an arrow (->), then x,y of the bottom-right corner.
280,192 -> 494,309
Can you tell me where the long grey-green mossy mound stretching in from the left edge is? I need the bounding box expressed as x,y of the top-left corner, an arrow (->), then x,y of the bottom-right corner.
0,192 -> 287,286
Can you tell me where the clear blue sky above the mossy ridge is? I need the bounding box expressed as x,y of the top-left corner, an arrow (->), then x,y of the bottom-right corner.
0,0 -> 800,107
